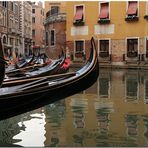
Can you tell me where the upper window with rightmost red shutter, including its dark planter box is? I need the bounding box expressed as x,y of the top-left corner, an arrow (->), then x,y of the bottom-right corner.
125,1 -> 138,21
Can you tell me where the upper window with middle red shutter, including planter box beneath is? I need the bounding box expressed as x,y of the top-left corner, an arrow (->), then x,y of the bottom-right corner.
98,2 -> 110,23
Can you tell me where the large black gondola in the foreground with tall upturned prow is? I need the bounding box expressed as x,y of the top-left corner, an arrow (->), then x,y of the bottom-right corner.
0,38 -> 99,119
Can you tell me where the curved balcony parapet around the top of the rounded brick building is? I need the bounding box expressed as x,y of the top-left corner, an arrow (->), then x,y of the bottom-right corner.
44,13 -> 66,25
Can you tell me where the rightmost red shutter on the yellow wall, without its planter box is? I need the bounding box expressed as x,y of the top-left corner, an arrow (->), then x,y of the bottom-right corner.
127,1 -> 137,15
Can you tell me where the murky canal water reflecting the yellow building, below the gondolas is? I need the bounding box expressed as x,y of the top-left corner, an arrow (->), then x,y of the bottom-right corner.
0,69 -> 148,147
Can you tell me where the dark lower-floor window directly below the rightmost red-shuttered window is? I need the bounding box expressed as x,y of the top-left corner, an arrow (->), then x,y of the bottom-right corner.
127,39 -> 138,57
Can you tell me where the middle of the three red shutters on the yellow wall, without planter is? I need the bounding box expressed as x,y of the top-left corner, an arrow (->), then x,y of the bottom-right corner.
99,3 -> 109,19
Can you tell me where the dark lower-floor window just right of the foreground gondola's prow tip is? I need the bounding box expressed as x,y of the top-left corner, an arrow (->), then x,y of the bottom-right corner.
99,39 -> 109,57
